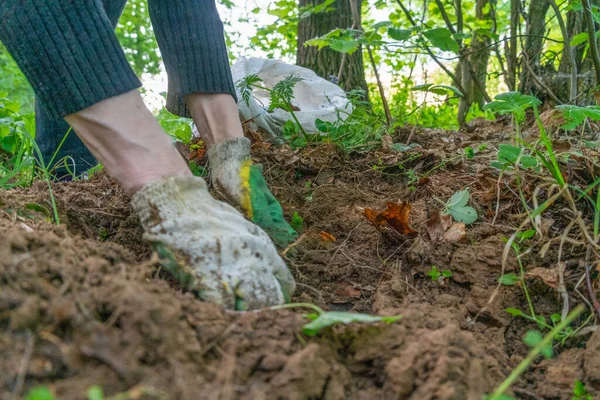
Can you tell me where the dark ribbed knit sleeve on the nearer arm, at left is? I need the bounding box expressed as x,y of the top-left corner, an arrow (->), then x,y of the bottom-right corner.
0,0 -> 141,119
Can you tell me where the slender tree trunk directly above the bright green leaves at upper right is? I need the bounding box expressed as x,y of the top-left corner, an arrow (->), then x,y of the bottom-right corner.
519,0 -> 550,98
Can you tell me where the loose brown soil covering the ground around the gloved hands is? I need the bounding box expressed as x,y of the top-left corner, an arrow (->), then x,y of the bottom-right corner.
0,121 -> 600,400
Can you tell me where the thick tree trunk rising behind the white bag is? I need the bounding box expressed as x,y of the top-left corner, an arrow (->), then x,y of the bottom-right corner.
296,0 -> 367,91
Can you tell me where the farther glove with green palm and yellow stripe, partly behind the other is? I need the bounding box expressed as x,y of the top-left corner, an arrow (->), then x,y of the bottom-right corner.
208,138 -> 298,247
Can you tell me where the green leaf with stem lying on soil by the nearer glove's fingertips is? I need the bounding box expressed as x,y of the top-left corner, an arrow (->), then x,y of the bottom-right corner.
271,303 -> 402,336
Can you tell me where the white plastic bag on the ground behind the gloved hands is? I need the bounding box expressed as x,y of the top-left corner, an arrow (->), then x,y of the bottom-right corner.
231,57 -> 352,137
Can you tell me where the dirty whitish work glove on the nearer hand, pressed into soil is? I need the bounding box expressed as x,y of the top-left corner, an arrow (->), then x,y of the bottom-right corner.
132,177 -> 296,310
